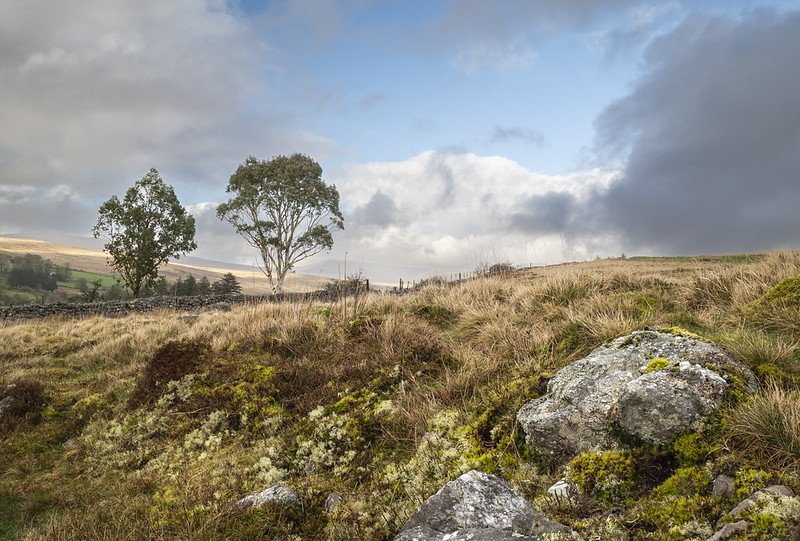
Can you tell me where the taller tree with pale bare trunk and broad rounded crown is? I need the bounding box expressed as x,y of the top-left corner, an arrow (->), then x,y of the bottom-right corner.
217,154 -> 344,294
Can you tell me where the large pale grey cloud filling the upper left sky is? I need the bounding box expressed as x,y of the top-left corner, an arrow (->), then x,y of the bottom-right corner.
0,0 -> 337,232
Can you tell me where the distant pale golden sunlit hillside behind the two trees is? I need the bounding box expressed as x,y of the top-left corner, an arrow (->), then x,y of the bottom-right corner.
0,237 -> 329,295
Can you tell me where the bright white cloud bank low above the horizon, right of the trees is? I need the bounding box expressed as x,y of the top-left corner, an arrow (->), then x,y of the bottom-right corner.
328,151 -> 614,281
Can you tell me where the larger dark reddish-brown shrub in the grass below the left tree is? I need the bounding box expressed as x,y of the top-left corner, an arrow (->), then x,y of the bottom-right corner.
128,340 -> 208,408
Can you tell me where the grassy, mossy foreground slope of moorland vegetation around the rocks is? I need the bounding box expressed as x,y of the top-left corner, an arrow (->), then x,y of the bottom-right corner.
0,253 -> 800,540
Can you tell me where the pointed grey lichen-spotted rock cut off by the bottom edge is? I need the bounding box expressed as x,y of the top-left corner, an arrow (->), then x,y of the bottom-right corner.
395,470 -> 570,541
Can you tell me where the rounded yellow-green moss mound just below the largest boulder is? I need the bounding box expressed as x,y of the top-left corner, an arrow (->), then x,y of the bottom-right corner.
568,451 -> 637,503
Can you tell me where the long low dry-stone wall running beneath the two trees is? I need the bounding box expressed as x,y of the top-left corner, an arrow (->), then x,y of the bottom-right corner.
0,291 -> 329,321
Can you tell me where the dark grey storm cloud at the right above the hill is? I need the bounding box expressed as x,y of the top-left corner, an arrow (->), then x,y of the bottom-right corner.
585,10 -> 800,253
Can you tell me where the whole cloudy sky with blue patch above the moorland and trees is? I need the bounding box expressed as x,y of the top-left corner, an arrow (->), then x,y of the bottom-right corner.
0,0 -> 800,283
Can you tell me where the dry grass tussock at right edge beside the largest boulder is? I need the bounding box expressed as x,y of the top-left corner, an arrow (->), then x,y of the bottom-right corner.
726,384 -> 800,468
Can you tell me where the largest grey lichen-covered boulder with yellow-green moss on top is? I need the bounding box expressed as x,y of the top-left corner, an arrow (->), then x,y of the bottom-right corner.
517,330 -> 757,463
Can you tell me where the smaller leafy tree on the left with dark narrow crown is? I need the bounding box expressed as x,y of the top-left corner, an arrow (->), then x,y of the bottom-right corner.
92,169 -> 197,297
